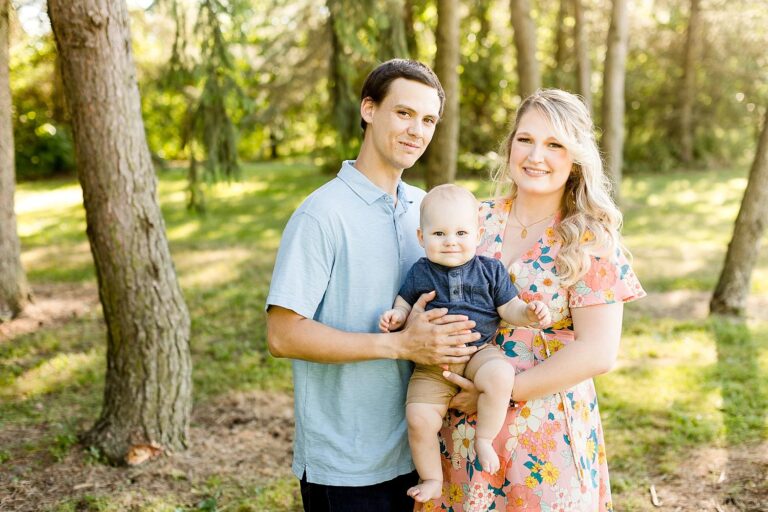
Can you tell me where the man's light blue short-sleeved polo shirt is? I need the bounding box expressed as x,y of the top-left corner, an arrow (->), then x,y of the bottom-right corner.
267,160 -> 424,486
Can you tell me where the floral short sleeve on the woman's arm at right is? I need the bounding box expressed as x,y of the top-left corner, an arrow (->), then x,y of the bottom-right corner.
568,249 -> 645,308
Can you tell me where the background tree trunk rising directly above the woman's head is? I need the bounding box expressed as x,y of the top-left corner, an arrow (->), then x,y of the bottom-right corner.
510,0 -> 541,99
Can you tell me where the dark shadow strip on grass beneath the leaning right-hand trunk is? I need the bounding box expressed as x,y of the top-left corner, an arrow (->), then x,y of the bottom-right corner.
712,317 -> 768,446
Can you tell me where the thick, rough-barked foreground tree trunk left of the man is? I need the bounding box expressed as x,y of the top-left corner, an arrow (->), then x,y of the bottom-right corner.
48,0 -> 192,462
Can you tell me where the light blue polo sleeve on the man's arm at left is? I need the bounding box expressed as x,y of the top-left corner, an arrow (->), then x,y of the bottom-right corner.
267,211 -> 334,318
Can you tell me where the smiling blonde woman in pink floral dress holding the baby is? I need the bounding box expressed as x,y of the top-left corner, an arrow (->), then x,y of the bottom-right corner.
416,90 -> 645,512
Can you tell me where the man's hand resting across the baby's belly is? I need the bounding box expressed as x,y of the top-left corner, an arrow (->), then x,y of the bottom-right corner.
399,291 -> 480,365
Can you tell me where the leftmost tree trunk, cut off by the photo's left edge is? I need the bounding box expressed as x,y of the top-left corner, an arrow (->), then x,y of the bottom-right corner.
0,0 -> 29,322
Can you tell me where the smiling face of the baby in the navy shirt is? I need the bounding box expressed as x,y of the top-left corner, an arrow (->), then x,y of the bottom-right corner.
418,200 -> 480,267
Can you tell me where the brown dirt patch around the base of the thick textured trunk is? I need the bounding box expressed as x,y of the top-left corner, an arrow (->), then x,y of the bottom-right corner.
0,392 -> 293,512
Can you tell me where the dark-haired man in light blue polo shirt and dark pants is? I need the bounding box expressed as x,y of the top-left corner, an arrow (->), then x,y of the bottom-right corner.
267,59 -> 479,512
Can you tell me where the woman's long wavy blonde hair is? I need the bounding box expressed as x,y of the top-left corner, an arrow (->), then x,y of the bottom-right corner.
492,89 -> 630,287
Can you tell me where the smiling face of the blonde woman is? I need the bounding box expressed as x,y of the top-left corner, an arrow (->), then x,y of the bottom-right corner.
509,108 -> 573,197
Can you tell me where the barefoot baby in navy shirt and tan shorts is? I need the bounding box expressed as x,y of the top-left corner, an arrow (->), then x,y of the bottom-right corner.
379,185 -> 551,502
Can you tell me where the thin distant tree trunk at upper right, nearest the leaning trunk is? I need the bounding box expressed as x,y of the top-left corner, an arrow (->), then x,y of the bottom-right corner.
678,0 -> 701,164
